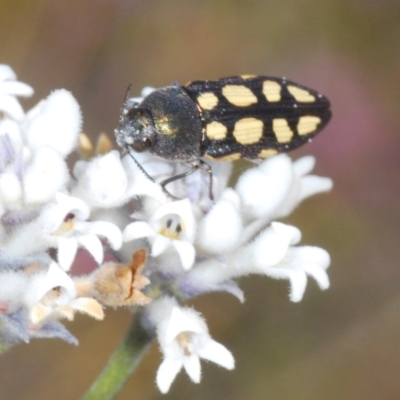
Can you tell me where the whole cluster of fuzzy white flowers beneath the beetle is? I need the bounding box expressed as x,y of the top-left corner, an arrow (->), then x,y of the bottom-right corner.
0,65 -> 332,393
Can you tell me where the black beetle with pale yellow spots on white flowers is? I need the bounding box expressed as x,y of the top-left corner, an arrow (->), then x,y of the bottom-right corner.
115,75 -> 331,197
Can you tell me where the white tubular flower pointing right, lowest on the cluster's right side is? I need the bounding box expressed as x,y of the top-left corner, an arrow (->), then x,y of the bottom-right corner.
177,222 -> 330,302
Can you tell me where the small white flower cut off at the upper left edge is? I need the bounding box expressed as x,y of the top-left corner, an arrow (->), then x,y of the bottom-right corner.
0,64 -> 33,121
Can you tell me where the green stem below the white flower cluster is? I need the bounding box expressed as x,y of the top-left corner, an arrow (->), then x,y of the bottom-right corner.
82,313 -> 153,400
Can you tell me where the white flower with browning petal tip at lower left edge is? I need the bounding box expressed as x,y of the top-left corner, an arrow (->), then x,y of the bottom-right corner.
0,262 -> 104,344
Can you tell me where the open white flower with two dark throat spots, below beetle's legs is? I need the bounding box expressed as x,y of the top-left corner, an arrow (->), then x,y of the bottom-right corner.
123,199 -> 196,270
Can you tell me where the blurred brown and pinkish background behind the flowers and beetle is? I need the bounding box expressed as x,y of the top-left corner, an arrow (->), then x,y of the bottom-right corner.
0,0 -> 400,400
